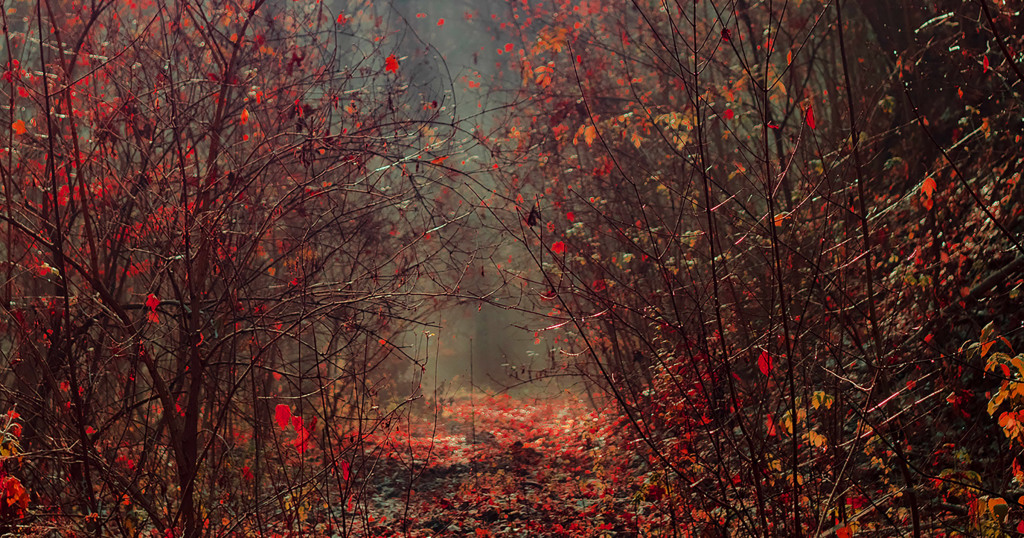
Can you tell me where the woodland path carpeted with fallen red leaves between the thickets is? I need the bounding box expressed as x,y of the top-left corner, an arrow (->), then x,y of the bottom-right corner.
339,389 -> 660,537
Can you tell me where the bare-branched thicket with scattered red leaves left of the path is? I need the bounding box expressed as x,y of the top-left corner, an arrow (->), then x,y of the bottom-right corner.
0,1 -> 468,536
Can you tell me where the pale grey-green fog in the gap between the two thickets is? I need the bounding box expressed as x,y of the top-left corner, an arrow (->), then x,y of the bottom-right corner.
337,0 -> 561,394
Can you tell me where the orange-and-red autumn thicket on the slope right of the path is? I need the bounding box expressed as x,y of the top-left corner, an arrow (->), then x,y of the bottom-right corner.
479,1 -> 1024,536
